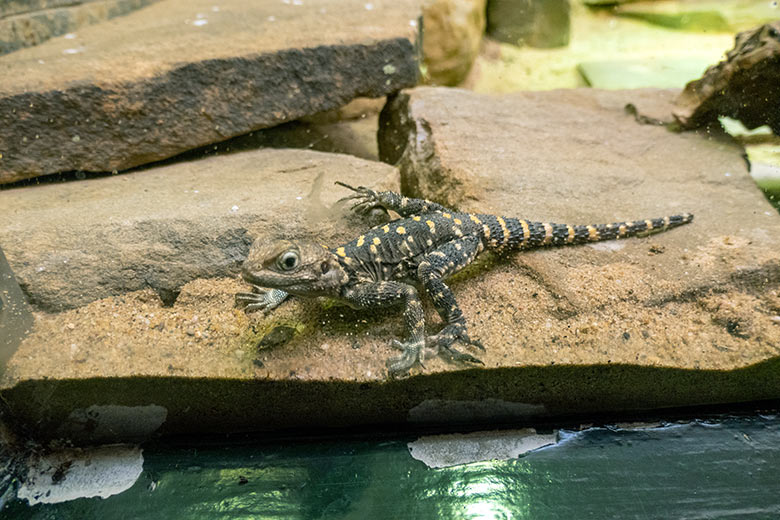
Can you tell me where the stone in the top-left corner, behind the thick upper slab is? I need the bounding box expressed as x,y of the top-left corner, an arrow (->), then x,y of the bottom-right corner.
0,0 -> 158,54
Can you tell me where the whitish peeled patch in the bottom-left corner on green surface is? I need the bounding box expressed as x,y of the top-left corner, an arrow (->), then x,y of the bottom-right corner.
18,446 -> 144,505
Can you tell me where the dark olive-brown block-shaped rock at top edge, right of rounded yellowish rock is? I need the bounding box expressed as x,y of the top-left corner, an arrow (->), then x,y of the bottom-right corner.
487,0 -> 571,48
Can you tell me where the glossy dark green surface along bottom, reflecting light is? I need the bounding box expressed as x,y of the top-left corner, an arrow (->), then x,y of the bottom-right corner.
4,415 -> 780,520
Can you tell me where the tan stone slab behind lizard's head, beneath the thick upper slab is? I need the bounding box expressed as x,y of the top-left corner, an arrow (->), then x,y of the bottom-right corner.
0,150 -> 395,311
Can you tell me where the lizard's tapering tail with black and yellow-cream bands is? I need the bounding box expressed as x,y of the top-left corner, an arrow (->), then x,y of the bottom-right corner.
480,213 -> 693,250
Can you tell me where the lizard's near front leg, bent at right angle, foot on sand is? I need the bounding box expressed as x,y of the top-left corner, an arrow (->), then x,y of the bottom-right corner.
343,282 -> 425,376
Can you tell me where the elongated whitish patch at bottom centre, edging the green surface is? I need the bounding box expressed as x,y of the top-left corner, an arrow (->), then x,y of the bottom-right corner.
407,428 -> 557,468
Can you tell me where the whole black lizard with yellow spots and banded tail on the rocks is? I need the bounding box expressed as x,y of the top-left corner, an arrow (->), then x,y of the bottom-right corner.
235,182 -> 693,377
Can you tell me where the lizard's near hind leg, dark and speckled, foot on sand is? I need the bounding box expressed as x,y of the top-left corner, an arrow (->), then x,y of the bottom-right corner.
417,237 -> 485,364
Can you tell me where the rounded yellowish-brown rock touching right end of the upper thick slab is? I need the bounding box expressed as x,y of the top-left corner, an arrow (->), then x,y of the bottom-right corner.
423,0 -> 486,86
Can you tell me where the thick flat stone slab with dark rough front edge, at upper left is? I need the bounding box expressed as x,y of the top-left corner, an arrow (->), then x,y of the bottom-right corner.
0,0 -> 420,183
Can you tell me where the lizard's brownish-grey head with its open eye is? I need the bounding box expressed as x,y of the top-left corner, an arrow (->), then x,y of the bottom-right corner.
241,240 -> 349,296
